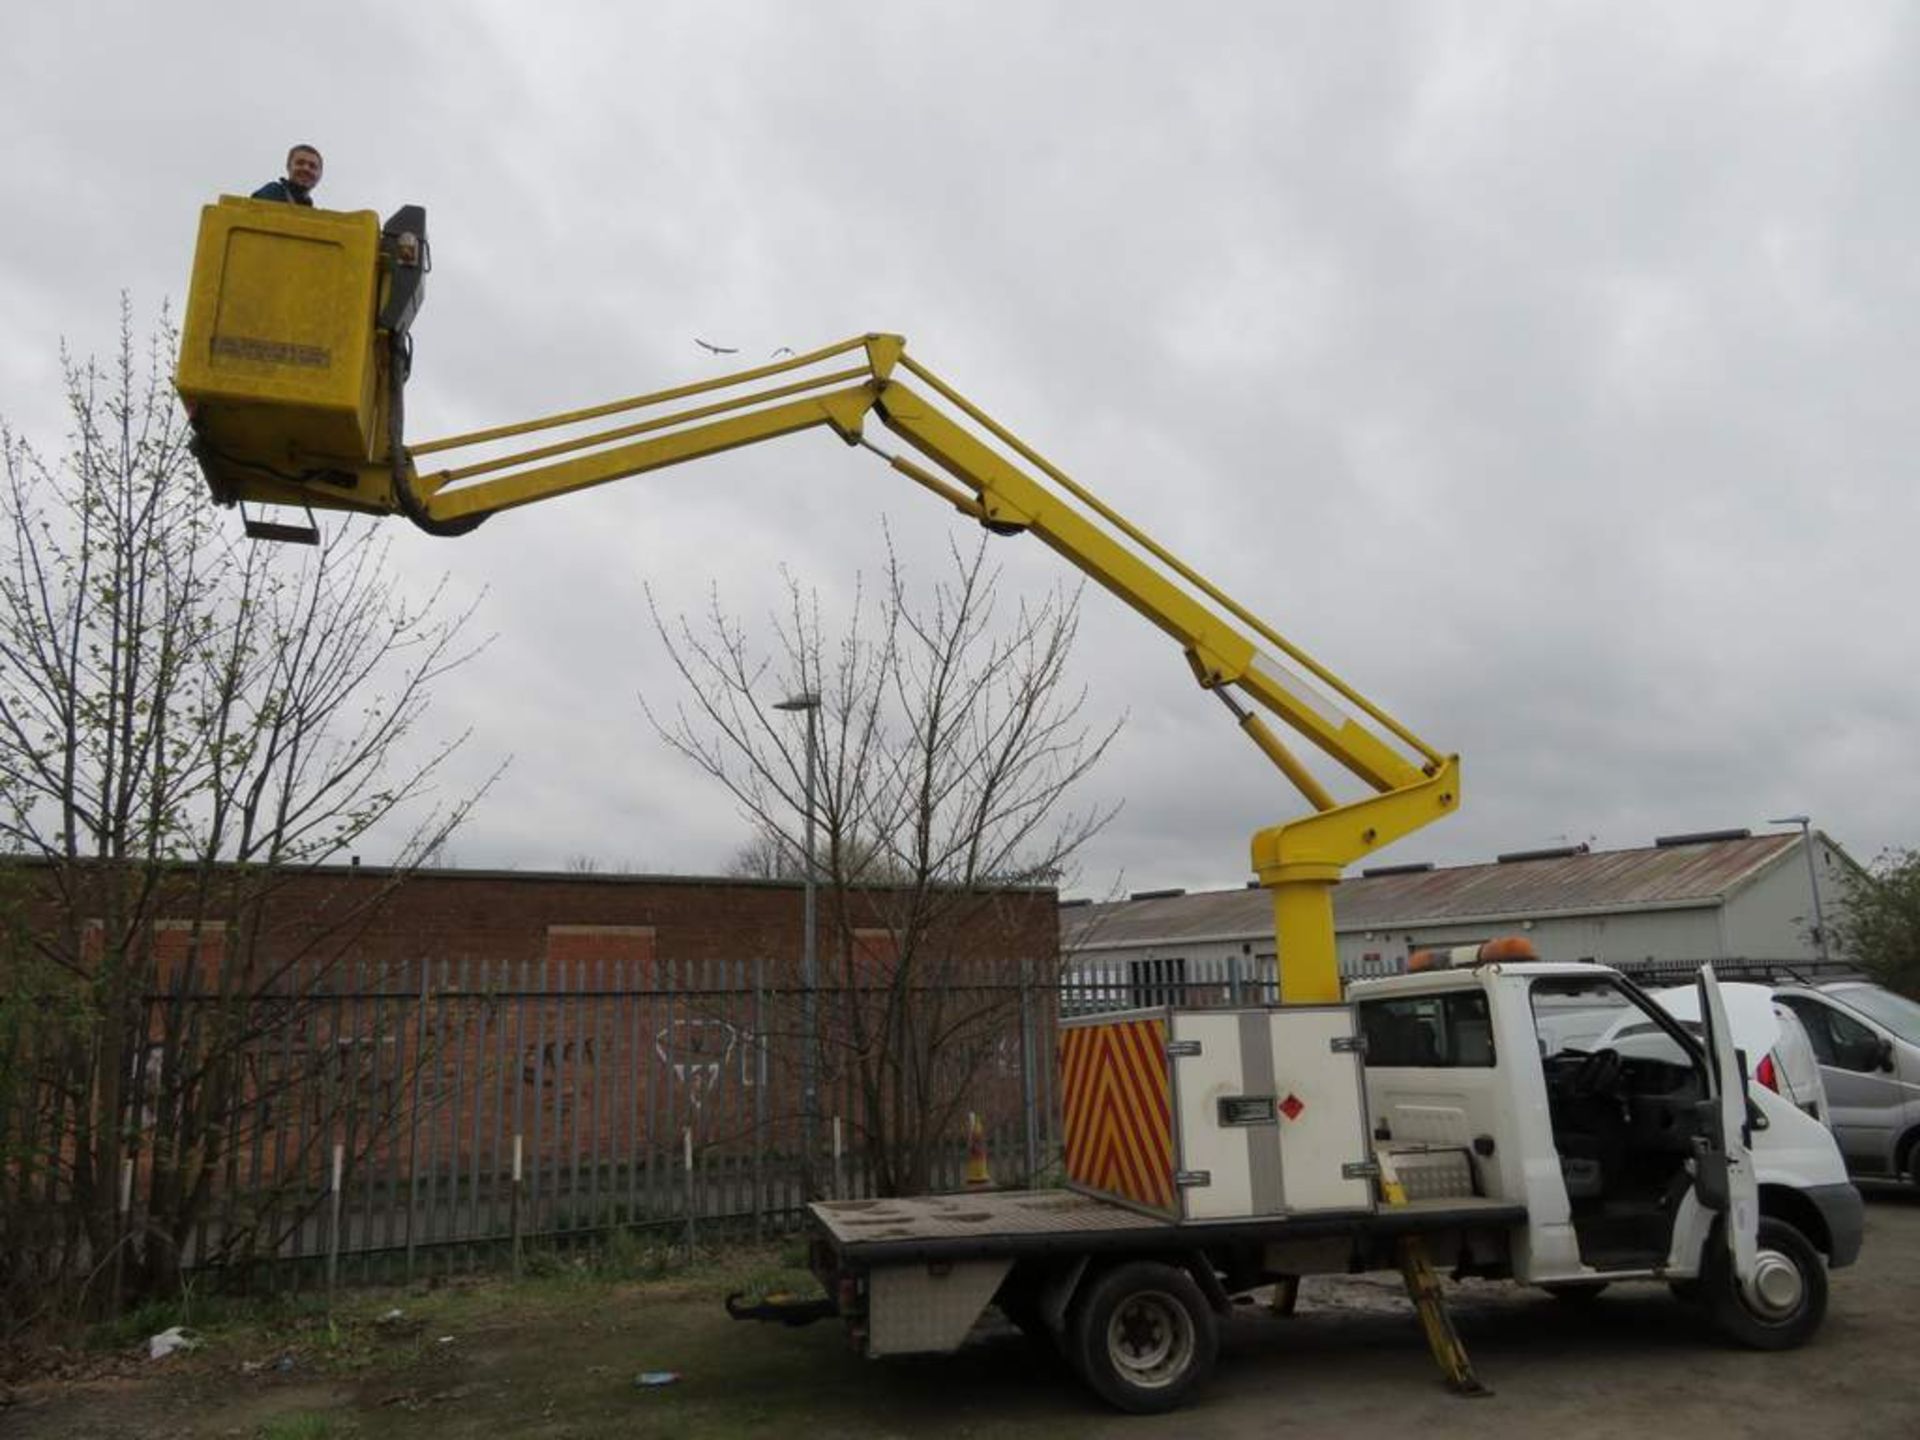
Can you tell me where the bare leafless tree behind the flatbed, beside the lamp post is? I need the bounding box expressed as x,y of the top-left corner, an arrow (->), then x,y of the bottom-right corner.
647,529 -> 1119,1192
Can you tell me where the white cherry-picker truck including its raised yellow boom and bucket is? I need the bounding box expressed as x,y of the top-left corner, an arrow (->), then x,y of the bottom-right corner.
175,208 -> 1860,1409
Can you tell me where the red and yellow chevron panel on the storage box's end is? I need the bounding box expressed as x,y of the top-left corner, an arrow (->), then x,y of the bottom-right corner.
1060,1020 -> 1179,1217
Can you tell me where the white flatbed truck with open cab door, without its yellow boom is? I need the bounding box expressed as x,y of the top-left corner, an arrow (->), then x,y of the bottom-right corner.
744,962 -> 1862,1411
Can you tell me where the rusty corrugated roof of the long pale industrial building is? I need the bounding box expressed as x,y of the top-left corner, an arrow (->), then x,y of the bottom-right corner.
1060,835 -> 1799,948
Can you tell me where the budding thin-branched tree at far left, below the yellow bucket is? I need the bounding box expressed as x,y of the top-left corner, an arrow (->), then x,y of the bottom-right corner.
0,301 -> 495,1317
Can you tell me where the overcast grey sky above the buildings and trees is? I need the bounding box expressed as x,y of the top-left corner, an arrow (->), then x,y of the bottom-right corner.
0,0 -> 1920,895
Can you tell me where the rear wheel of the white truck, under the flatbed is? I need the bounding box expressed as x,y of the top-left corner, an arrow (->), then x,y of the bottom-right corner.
1068,1260 -> 1219,1415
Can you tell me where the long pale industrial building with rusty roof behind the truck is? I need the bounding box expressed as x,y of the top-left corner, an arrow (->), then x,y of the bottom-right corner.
1060,829 -> 1859,1004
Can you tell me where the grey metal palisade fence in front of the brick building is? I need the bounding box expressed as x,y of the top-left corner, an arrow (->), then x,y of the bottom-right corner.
0,956 -> 1858,1286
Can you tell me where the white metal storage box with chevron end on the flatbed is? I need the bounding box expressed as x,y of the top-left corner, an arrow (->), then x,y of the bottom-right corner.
1060,1006 -> 1375,1221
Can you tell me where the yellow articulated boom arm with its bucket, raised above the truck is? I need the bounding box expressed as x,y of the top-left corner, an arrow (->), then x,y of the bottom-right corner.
177,200 -> 1459,1004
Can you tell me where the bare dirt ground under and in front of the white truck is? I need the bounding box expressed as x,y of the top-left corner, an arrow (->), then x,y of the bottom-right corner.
15,1188 -> 1920,1440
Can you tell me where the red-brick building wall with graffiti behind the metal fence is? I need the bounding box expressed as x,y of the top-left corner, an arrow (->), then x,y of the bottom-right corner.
7,866 -> 1058,1187
